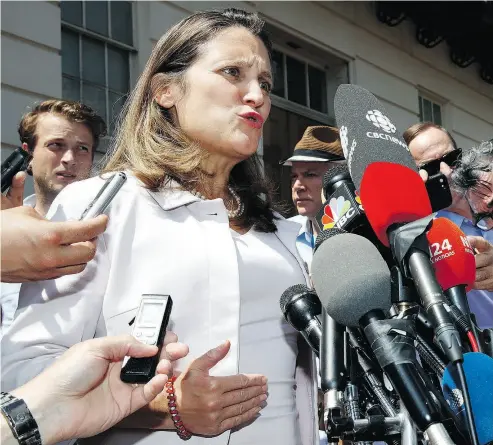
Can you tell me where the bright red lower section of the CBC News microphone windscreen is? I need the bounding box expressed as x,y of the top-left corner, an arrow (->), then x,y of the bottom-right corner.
360,162 -> 432,247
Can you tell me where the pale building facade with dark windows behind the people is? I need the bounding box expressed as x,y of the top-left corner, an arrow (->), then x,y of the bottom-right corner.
1,1 -> 493,200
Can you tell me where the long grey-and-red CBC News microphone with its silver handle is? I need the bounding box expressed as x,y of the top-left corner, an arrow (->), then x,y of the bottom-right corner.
334,85 -> 462,361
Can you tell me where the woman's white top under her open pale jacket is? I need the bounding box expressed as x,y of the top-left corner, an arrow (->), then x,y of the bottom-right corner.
229,230 -> 305,445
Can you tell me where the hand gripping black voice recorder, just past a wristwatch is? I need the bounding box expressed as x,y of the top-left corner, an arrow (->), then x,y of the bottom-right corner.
12,333 -> 188,444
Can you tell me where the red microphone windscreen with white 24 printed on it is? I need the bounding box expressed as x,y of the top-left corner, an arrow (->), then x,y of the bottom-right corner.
426,218 -> 476,291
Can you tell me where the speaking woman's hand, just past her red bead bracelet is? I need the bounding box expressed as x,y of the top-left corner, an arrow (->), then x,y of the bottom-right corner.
150,341 -> 267,436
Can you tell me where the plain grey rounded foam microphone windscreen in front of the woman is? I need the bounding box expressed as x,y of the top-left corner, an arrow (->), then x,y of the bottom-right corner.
311,233 -> 391,327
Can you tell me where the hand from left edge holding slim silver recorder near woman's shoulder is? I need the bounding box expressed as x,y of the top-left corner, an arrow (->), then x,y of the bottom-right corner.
0,206 -> 108,283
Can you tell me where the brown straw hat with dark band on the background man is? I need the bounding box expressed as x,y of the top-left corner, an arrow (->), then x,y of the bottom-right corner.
280,125 -> 345,166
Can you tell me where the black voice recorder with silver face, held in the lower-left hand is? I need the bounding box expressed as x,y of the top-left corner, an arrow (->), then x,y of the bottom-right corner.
120,294 -> 173,383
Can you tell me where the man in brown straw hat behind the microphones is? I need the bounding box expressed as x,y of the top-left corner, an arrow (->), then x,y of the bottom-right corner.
282,125 -> 346,268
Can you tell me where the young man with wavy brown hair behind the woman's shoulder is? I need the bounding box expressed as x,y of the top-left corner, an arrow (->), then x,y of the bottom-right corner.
0,99 -> 106,333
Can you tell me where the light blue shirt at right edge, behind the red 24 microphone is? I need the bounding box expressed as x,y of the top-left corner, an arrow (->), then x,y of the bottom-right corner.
437,210 -> 493,329
